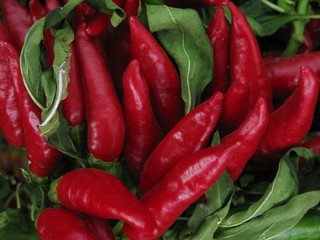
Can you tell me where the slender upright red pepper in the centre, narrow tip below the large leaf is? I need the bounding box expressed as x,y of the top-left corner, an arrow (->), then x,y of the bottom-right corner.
122,60 -> 163,178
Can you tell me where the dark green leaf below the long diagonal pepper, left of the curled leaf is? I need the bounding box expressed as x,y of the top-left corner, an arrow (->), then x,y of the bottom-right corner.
187,172 -> 235,233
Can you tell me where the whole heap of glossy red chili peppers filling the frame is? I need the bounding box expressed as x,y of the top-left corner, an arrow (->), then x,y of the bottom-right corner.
0,0 -> 320,240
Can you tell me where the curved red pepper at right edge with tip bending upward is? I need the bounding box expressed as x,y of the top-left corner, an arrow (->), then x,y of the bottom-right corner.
256,66 -> 320,157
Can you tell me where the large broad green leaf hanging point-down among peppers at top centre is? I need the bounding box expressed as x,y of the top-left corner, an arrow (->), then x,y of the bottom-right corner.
146,5 -> 213,113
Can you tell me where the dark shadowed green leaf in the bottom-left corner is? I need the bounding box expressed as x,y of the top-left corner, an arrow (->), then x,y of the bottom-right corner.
0,208 -> 40,240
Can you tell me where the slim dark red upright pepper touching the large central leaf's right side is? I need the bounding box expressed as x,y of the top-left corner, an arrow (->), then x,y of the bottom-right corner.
205,7 -> 229,99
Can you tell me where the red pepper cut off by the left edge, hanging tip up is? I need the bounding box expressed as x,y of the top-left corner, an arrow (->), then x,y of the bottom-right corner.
0,39 -> 25,147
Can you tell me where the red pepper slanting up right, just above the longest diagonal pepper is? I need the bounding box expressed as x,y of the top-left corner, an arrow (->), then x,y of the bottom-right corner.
140,92 -> 223,193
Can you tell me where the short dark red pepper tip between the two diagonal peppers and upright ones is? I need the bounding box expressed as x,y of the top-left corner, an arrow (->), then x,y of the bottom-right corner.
218,77 -> 250,136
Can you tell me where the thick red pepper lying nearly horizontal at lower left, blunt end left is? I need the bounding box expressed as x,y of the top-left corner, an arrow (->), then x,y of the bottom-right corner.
56,168 -> 156,234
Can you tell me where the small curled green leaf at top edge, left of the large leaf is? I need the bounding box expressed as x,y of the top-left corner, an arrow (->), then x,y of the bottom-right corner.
86,0 -> 126,27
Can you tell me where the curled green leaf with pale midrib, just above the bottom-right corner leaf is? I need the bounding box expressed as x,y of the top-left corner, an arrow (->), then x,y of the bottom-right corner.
222,148 -> 311,227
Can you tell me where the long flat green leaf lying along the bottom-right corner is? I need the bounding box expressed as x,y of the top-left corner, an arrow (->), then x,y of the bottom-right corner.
214,191 -> 320,240
